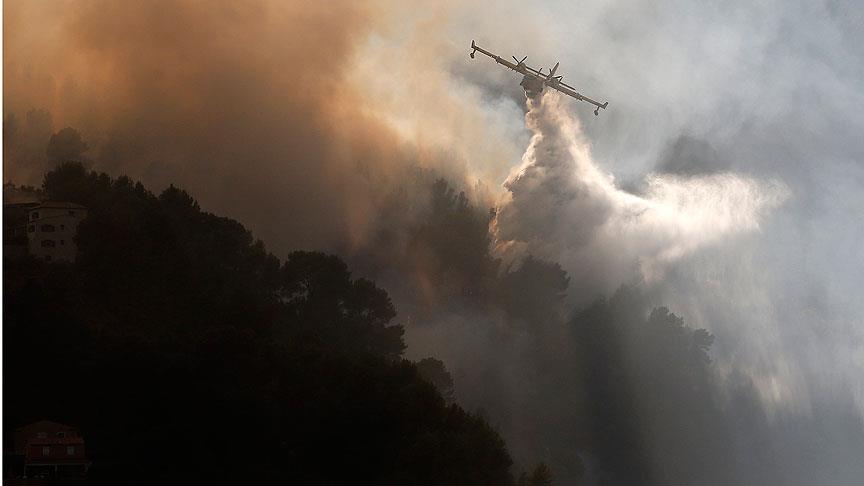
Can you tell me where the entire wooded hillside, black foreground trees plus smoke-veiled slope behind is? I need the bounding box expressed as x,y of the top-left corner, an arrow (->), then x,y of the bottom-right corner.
10,164 -> 852,486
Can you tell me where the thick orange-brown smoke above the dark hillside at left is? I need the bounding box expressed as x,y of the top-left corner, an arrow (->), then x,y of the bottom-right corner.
4,0 -> 492,253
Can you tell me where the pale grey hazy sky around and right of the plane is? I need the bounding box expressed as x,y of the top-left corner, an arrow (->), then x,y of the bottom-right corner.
362,1 -> 864,422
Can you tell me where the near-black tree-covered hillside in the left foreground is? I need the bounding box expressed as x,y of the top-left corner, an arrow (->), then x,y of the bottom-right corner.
4,164 -> 512,484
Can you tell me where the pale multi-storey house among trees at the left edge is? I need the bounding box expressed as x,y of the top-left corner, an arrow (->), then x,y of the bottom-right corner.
27,201 -> 87,262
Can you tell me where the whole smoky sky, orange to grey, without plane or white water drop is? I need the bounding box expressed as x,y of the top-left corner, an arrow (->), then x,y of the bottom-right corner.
4,0 -> 864,432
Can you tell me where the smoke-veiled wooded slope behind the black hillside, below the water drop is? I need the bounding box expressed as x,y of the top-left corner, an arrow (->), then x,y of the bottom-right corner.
362,174 -> 788,484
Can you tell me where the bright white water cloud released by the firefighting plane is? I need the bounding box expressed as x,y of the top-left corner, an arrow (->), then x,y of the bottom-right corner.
494,94 -> 788,297
